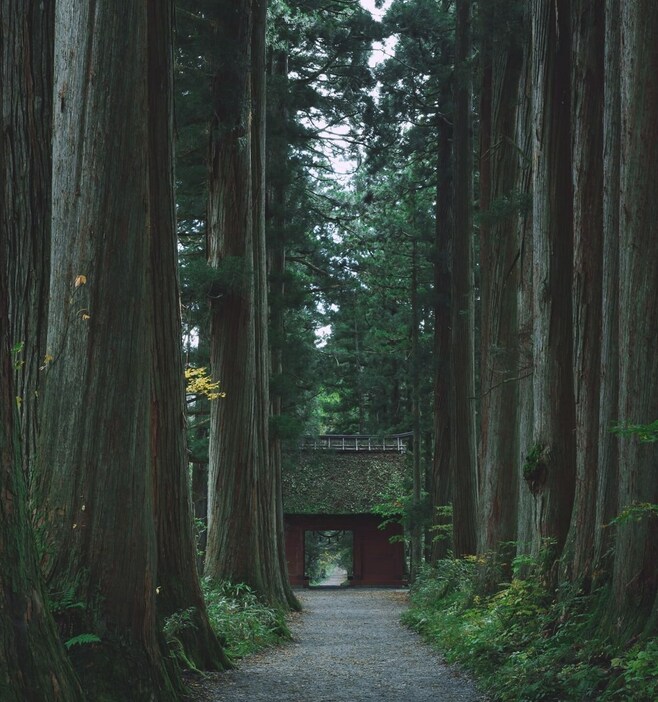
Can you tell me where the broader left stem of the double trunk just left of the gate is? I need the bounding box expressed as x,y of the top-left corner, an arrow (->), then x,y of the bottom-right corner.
205,0 -> 258,592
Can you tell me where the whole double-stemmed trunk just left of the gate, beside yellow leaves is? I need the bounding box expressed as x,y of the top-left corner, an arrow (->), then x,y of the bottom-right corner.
206,0 -> 291,606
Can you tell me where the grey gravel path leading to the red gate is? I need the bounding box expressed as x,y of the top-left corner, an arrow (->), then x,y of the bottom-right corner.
184,588 -> 486,702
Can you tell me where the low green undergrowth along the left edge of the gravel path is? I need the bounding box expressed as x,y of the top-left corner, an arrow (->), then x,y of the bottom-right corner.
202,578 -> 290,660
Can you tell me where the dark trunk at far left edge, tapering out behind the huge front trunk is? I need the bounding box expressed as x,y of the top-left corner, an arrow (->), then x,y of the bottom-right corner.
0,2 -> 55,479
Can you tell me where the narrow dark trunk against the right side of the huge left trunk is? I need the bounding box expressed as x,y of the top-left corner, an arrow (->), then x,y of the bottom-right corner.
148,0 -> 230,670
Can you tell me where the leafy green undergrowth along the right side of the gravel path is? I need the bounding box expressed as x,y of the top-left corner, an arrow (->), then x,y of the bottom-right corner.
403,558 -> 658,702
